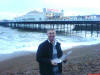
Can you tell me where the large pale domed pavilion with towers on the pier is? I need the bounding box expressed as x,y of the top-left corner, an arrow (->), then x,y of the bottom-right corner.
14,8 -> 64,21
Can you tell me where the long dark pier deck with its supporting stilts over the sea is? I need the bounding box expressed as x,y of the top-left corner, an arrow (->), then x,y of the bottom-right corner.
0,21 -> 100,37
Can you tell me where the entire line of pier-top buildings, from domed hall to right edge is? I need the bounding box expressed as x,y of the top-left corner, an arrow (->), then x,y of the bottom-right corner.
14,8 -> 100,21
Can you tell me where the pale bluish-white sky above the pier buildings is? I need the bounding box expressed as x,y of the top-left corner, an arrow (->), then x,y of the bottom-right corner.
0,0 -> 100,20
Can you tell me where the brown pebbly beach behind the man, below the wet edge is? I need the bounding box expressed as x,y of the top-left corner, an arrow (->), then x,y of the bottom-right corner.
0,44 -> 100,75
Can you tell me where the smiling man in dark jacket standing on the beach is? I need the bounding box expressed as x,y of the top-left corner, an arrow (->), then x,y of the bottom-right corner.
36,29 -> 66,75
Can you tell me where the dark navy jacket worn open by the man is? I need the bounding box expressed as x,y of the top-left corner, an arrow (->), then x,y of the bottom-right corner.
36,40 -> 62,75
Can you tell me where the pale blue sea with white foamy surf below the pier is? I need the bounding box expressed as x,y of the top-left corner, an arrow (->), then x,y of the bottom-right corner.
0,26 -> 100,61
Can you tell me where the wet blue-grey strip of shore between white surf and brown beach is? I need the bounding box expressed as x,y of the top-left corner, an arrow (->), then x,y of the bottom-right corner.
0,43 -> 100,62
